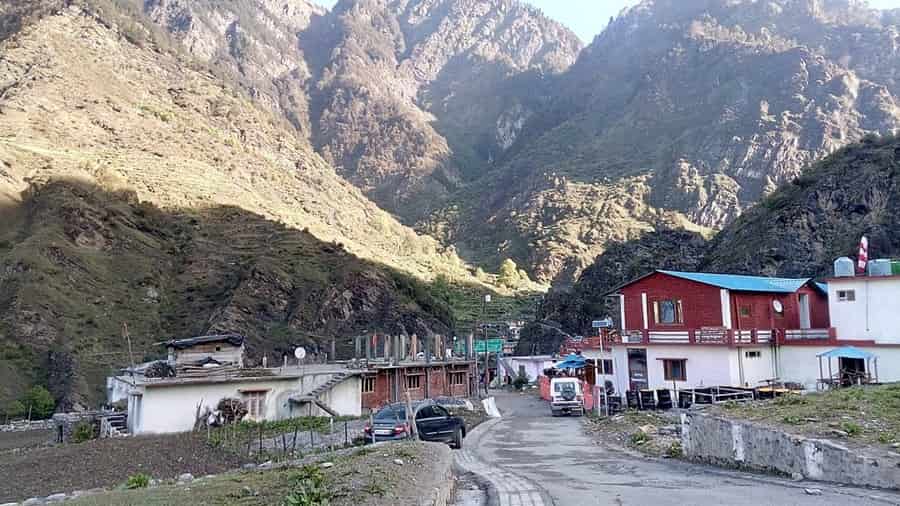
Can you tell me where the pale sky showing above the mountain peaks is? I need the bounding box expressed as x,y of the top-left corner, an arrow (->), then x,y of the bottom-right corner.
313,0 -> 900,44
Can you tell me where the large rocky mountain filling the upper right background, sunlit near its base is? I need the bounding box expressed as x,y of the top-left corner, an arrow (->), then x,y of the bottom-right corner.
430,0 -> 900,287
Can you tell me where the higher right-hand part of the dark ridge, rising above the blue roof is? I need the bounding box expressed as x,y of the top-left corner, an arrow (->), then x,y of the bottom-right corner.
703,133 -> 900,276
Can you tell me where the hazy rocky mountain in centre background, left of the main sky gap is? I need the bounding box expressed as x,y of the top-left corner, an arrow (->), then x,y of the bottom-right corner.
143,0 -> 581,219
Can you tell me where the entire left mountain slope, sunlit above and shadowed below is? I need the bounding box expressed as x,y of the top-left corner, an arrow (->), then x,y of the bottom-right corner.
0,0 -> 484,407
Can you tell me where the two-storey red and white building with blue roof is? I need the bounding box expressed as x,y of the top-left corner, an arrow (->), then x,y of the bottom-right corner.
583,271 -> 836,392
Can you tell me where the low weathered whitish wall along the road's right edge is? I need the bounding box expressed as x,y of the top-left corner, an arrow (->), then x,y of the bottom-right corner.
681,413 -> 900,489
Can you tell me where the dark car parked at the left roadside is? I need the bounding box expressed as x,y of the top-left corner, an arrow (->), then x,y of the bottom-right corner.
365,400 -> 466,448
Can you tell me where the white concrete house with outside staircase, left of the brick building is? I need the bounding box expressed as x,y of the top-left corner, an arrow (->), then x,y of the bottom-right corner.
128,335 -> 362,434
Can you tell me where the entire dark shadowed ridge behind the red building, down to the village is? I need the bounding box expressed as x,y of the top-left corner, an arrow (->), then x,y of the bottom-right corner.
536,136 -> 900,340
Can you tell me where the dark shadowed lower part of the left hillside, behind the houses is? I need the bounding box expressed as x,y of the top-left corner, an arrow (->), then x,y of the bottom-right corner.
0,181 -> 453,410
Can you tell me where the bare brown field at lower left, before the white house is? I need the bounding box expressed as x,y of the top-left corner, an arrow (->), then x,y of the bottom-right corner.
0,434 -> 241,503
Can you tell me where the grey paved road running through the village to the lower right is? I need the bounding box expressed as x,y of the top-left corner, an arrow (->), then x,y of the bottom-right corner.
457,393 -> 900,506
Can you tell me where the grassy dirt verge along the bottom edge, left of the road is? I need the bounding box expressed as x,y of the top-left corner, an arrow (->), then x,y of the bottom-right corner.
67,442 -> 449,506
